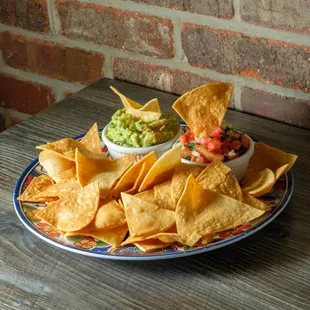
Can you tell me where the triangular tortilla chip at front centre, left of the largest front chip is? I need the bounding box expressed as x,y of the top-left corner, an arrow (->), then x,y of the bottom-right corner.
121,193 -> 175,237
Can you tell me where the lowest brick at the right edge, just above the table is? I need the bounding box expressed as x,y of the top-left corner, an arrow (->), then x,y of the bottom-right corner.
241,87 -> 310,129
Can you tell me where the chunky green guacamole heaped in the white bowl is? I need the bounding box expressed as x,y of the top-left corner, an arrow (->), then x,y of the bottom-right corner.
106,109 -> 180,147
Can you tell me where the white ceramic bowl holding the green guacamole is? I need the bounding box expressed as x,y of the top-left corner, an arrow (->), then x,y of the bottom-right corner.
102,125 -> 181,161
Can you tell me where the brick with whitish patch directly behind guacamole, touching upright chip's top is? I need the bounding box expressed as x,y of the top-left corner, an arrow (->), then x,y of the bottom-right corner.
113,57 -> 212,95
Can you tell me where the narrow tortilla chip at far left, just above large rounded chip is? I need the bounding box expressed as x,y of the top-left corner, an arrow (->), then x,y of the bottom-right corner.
38,180 -> 81,198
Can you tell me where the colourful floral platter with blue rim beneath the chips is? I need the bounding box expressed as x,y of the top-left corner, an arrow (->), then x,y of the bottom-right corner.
14,126 -> 292,259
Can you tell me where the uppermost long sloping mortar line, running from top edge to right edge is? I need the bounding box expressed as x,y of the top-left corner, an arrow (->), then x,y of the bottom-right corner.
80,0 -> 310,46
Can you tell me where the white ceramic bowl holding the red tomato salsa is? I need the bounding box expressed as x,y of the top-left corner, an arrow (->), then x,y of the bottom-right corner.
175,135 -> 254,182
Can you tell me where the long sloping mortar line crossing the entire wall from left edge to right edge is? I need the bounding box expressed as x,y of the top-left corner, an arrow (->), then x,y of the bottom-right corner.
2,25 -> 310,100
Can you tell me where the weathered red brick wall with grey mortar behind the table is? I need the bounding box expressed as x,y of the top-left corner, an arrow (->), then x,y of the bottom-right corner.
0,0 -> 310,129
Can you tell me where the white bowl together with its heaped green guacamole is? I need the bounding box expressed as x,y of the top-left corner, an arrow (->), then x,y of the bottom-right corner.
102,109 -> 181,158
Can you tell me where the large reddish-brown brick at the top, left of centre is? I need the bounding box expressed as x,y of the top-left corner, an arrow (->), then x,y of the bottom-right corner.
57,0 -> 174,58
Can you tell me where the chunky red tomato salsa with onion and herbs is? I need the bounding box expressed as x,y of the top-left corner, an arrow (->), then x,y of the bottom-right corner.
179,125 -> 250,164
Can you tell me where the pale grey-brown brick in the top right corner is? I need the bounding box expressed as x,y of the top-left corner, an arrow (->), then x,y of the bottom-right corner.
240,0 -> 310,34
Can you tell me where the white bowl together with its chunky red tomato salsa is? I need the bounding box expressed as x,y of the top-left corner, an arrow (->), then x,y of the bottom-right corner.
175,125 -> 254,181
